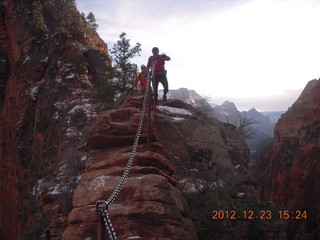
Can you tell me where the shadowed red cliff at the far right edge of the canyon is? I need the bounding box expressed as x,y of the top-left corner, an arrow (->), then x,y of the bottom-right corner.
261,80 -> 320,239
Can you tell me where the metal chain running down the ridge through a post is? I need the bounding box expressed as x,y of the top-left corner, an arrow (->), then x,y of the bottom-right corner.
96,72 -> 151,240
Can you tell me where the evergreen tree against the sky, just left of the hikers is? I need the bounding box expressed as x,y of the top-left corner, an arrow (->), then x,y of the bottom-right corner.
108,32 -> 141,91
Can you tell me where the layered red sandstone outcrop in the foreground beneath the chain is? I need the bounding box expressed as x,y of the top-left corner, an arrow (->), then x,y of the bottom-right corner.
63,100 -> 196,239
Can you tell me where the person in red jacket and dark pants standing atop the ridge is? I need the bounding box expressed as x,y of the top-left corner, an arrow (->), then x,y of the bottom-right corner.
147,47 -> 171,103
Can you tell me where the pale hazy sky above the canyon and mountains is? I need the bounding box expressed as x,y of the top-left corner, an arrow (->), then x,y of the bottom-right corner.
77,0 -> 320,110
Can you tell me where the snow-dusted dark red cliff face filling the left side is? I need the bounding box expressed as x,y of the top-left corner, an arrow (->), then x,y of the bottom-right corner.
0,0 -> 108,239
